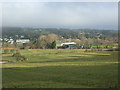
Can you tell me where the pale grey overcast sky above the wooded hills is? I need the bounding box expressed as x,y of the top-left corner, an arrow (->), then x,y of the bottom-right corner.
2,2 -> 118,29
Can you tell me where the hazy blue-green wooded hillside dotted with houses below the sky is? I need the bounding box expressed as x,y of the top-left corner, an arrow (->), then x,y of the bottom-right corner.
2,27 -> 118,40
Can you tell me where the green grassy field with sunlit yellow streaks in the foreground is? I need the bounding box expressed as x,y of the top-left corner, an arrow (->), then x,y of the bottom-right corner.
2,49 -> 118,88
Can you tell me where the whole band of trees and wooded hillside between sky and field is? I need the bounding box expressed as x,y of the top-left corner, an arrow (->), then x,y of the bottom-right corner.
2,27 -> 118,49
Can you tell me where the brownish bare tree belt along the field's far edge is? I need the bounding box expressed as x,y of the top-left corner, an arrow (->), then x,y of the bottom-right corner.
2,34 -> 118,49
